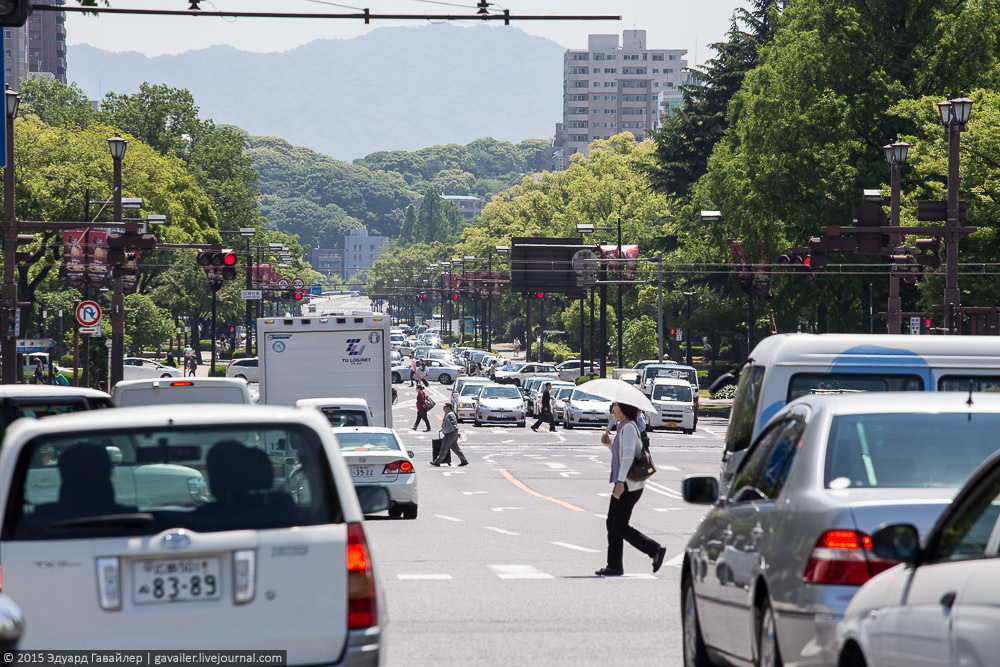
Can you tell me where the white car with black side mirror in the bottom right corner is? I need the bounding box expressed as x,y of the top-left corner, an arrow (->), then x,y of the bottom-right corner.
837,444 -> 1000,667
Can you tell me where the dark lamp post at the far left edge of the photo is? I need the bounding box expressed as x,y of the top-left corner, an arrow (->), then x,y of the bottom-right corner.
0,88 -> 21,384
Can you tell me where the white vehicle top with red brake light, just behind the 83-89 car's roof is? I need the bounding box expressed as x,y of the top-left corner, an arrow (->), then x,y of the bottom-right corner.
111,377 -> 251,408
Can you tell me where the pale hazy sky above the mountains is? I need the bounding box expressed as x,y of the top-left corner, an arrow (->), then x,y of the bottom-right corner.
66,0 -> 741,69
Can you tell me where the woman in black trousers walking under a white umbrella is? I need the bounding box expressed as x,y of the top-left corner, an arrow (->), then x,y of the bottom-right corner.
595,402 -> 667,577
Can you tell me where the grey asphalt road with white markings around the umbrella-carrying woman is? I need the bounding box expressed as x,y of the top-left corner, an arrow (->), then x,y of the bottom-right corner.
366,384 -> 726,666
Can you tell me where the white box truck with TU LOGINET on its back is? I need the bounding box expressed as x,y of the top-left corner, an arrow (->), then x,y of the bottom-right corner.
257,313 -> 392,428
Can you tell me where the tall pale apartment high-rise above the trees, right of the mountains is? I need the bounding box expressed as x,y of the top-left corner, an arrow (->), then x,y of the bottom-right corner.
561,30 -> 689,168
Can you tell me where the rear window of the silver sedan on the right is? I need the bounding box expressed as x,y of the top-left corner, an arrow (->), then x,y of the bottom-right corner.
825,412 -> 1000,489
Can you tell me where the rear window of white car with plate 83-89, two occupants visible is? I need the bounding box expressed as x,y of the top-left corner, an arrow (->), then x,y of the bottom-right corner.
2,424 -> 343,540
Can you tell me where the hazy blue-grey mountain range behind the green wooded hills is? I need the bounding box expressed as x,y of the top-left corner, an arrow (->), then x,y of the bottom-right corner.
67,24 -> 565,160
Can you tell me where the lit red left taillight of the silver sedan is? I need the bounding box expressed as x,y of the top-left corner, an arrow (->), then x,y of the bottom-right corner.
802,530 -> 895,586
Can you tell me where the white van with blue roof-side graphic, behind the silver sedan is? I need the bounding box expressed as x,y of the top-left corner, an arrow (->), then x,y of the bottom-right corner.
712,334 -> 1000,487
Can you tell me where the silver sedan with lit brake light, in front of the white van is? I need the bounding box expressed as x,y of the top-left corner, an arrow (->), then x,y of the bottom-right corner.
681,393 -> 1000,666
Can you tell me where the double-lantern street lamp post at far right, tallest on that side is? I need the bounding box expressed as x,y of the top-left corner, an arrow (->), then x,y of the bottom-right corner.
937,96 -> 973,334
